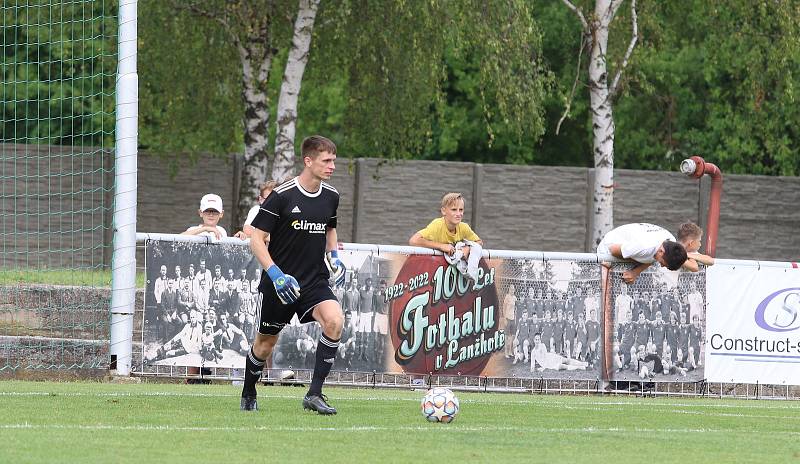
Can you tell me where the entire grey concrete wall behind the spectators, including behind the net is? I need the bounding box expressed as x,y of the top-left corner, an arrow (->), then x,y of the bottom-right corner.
0,145 -> 800,267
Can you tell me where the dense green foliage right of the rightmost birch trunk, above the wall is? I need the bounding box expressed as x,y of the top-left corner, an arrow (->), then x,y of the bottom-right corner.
615,0 -> 800,175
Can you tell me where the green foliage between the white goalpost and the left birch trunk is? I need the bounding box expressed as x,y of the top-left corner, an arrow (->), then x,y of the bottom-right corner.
138,0 -> 250,160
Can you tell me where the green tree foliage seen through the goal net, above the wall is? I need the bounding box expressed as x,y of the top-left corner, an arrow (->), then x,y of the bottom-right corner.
0,0 -> 117,146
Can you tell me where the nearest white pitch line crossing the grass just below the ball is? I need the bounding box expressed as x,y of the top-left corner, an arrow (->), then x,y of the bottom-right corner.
0,422 -> 800,436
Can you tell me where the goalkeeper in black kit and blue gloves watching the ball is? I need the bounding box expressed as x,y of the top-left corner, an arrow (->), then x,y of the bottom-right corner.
241,136 -> 345,414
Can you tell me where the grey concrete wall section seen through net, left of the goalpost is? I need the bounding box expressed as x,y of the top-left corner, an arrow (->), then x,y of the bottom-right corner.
0,144 -> 113,269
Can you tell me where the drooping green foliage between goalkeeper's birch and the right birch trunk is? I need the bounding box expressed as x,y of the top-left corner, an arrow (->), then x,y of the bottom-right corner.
312,0 -> 549,162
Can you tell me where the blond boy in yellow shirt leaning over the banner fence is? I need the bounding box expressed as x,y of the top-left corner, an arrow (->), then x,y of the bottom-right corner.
408,193 -> 483,259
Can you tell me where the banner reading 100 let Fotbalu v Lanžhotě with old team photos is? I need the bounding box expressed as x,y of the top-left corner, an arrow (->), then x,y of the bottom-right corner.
142,241 -> 602,380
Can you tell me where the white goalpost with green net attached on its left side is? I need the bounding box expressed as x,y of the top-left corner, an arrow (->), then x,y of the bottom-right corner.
110,0 -> 139,375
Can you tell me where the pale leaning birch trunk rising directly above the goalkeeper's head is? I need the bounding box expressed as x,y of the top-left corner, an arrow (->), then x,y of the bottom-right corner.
272,0 -> 320,180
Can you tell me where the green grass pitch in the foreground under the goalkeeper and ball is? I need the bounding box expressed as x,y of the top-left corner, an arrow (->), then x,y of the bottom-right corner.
0,381 -> 800,464
